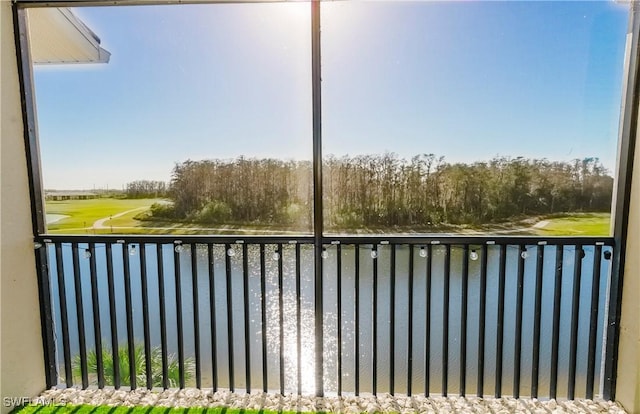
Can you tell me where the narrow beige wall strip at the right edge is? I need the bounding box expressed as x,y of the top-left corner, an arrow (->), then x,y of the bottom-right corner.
616,114 -> 640,413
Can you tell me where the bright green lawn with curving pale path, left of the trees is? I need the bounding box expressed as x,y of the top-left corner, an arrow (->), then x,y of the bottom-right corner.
46,198 -> 159,234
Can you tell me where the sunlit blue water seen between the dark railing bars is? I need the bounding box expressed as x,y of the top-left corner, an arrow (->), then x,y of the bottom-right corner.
50,244 -> 610,397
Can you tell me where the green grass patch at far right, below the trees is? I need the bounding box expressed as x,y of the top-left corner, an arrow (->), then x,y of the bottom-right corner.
535,213 -> 611,236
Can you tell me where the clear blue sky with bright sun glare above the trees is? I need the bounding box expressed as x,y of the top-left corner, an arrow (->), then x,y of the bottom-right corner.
35,1 -> 628,189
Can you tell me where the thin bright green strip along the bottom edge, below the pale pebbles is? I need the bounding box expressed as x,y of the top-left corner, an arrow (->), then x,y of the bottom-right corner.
12,405 -> 308,414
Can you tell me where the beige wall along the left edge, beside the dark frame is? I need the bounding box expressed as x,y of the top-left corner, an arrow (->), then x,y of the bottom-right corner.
0,0 -> 45,413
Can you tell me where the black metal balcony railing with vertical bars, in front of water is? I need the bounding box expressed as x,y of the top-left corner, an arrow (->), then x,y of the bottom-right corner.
38,236 -> 613,399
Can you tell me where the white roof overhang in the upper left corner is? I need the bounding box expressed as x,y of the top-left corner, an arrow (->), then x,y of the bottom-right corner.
28,7 -> 111,64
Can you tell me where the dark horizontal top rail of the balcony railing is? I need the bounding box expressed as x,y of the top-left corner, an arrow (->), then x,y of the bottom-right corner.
35,234 -> 615,246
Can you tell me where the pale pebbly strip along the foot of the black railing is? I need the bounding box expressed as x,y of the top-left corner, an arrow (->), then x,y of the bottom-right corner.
41,388 -> 625,414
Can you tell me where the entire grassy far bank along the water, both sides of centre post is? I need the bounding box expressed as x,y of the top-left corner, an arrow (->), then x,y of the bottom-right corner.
46,198 -> 610,237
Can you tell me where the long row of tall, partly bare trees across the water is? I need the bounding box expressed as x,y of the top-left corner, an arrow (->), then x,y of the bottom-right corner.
142,153 -> 613,229
